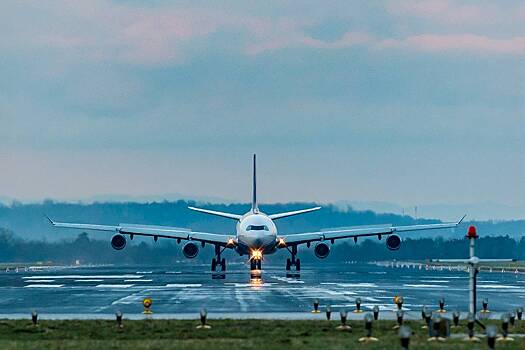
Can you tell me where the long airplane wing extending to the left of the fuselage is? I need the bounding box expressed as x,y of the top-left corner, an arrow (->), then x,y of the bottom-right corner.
47,217 -> 235,246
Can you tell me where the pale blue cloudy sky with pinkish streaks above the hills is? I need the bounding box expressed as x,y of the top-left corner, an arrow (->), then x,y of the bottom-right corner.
0,0 -> 525,217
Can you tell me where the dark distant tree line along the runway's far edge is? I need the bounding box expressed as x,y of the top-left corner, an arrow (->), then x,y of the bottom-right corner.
0,229 -> 525,265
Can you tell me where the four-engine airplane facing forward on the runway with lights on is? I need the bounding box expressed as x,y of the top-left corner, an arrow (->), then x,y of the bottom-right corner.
47,154 -> 466,273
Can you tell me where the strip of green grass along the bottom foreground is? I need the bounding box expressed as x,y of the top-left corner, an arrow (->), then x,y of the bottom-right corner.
0,320 -> 525,350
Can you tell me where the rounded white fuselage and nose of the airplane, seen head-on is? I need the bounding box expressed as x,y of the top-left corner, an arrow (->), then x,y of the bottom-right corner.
236,211 -> 277,254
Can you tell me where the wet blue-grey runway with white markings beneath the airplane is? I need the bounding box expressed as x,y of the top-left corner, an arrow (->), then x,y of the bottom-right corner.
0,262 -> 525,317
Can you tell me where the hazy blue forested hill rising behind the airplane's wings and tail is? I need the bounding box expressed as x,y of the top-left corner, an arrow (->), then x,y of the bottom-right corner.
0,200 -> 525,241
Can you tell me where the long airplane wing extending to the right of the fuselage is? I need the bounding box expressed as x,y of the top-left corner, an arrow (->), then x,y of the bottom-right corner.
278,215 -> 466,247
